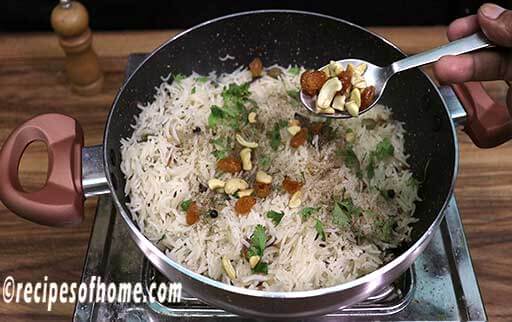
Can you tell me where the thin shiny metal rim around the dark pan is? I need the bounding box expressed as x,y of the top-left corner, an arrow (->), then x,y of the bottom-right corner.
103,9 -> 459,299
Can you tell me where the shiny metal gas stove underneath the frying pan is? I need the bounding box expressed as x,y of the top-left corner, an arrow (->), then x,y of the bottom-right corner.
74,54 -> 487,321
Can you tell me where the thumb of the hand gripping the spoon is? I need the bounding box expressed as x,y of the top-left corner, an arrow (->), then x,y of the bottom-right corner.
478,3 -> 512,47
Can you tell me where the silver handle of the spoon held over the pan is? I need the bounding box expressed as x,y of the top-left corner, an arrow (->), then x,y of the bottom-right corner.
391,32 -> 494,74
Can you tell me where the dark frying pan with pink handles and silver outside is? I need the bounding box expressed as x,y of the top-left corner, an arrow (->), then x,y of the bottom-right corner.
0,10 -> 512,318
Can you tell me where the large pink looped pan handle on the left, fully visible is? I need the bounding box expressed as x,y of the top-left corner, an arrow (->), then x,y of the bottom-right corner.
0,114 -> 84,226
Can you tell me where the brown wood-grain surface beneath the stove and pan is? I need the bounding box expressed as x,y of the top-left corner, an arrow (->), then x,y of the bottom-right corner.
0,27 -> 512,321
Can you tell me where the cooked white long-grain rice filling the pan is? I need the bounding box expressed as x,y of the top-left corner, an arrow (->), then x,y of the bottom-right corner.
121,67 -> 418,291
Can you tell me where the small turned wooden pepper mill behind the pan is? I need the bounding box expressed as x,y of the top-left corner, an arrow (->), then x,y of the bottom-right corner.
51,0 -> 103,96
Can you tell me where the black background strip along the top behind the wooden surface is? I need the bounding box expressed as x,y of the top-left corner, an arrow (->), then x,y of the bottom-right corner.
0,0 -> 512,31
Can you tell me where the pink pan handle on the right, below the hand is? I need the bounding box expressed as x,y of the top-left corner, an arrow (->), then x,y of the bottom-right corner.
452,82 -> 512,148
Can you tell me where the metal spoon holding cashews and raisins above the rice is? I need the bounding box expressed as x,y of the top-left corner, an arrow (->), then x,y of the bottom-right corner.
300,32 -> 494,118
